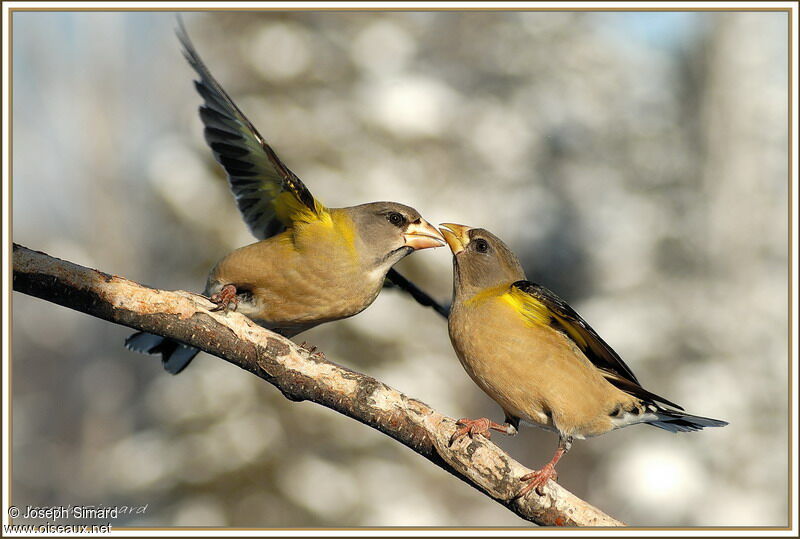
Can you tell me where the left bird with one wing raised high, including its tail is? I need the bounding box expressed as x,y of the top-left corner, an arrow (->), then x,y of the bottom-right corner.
126,25 -> 444,373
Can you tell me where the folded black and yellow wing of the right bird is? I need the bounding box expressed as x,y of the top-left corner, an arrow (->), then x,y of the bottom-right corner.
511,281 -> 683,410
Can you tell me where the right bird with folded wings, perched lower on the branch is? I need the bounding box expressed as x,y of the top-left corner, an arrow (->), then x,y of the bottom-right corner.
440,223 -> 727,495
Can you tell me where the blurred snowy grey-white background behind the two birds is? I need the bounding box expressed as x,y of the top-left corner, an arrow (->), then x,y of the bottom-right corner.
12,12 -> 788,527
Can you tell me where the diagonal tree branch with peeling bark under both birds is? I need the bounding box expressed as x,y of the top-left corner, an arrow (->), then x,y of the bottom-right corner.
14,244 -> 624,526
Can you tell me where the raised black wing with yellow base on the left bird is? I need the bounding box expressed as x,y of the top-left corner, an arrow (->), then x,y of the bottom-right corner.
176,19 -> 326,239
